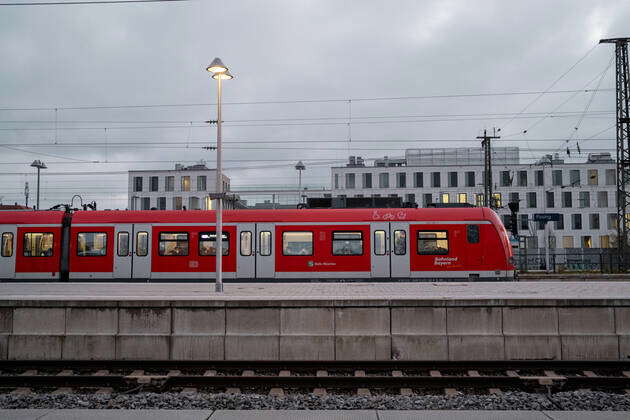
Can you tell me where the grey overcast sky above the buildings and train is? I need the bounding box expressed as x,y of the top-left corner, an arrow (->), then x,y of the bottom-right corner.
0,0 -> 630,208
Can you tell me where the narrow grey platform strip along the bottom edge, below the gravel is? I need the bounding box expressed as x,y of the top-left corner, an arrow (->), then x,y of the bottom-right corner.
0,409 -> 630,420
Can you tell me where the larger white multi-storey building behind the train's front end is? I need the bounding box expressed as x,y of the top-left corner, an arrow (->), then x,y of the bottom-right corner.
331,147 -> 617,248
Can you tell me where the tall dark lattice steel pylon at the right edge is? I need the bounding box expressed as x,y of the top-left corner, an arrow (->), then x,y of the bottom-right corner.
599,38 -> 630,271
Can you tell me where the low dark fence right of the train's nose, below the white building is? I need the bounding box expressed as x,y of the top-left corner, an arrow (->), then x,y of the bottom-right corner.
514,248 -> 630,273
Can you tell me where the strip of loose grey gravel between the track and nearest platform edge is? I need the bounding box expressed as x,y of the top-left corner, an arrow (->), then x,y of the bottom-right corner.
0,391 -> 630,411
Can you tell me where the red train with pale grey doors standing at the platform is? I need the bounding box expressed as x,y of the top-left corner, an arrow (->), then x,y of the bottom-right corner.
0,208 -> 514,281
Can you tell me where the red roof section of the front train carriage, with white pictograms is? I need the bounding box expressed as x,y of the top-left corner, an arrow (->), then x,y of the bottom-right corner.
72,207 -> 496,223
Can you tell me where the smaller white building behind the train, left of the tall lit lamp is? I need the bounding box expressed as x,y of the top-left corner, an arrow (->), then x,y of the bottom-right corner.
128,163 -> 232,210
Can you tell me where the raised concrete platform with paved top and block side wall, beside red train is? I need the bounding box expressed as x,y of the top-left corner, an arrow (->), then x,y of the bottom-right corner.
0,282 -> 630,360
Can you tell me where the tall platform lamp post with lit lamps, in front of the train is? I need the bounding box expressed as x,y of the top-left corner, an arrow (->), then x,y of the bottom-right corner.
206,57 -> 233,293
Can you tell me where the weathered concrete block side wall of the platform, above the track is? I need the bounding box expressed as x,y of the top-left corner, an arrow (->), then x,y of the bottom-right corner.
0,300 -> 630,360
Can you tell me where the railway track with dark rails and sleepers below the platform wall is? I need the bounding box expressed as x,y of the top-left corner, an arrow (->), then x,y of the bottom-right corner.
0,361 -> 630,396
